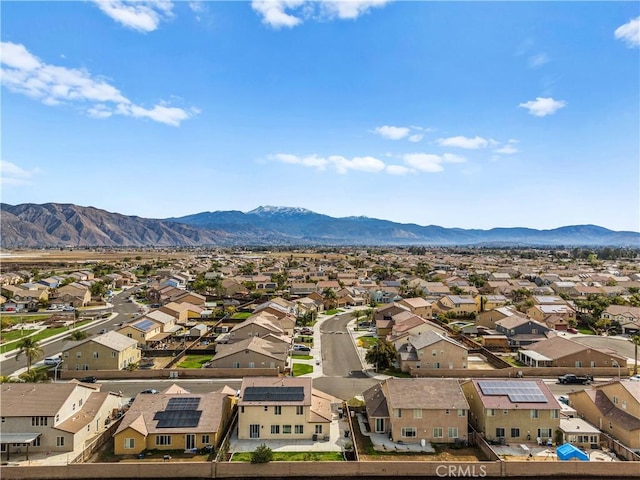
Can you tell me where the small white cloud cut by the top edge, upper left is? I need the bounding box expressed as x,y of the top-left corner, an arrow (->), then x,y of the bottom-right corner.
93,0 -> 173,32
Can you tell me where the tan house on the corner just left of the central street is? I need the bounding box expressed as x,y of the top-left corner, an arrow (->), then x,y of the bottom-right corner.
209,337 -> 290,373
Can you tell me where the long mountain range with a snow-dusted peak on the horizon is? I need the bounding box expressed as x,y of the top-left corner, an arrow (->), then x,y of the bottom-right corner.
0,203 -> 640,248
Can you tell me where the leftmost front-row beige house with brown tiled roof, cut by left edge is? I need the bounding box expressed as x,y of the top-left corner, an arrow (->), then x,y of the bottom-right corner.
0,381 -> 122,459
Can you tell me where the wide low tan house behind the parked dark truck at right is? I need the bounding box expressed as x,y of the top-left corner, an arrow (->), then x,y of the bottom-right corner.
518,335 -> 627,369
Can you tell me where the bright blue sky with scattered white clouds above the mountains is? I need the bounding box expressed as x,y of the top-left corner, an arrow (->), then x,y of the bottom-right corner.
0,0 -> 640,231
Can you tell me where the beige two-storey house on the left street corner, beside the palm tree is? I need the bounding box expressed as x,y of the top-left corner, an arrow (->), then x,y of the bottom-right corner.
62,331 -> 141,370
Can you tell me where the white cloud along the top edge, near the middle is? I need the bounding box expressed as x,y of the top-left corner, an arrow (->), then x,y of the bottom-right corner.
251,0 -> 390,29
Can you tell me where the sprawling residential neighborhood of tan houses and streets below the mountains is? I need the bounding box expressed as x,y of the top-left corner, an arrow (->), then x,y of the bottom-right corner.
0,249 -> 640,474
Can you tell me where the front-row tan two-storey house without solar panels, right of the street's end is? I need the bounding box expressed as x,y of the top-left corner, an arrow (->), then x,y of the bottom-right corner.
363,377 -> 469,443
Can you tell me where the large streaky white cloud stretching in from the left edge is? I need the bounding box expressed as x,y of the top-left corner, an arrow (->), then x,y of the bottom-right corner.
0,42 -> 198,126
